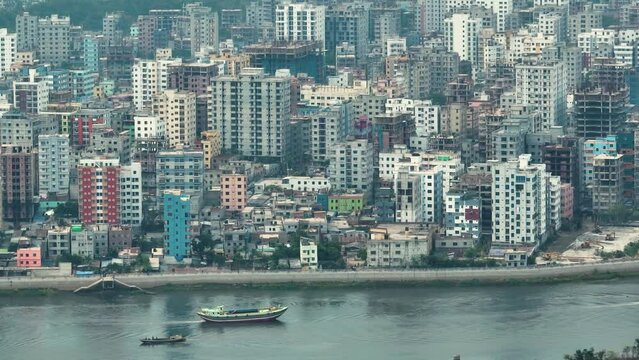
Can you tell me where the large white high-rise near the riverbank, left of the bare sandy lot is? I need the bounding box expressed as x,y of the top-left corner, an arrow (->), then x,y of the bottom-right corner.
492,154 -> 550,244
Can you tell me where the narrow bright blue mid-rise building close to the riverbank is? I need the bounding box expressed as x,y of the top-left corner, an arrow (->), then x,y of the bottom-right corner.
163,190 -> 191,261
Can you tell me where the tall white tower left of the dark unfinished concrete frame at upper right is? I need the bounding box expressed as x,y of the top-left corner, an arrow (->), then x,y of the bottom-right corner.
515,60 -> 567,130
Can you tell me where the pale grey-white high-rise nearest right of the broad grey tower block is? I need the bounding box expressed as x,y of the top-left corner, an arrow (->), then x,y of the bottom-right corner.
311,102 -> 354,161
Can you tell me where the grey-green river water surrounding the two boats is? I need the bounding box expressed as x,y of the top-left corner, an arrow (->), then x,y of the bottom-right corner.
0,280 -> 639,360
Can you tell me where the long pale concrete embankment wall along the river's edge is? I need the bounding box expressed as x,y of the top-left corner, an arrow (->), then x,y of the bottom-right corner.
0,261 -> 639,291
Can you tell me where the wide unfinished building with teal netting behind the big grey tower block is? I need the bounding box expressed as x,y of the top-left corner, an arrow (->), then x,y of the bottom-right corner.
244,41 -> 326,82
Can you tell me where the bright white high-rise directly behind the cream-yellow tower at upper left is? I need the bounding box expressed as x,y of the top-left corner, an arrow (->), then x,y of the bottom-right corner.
131,59 -> 182,111
